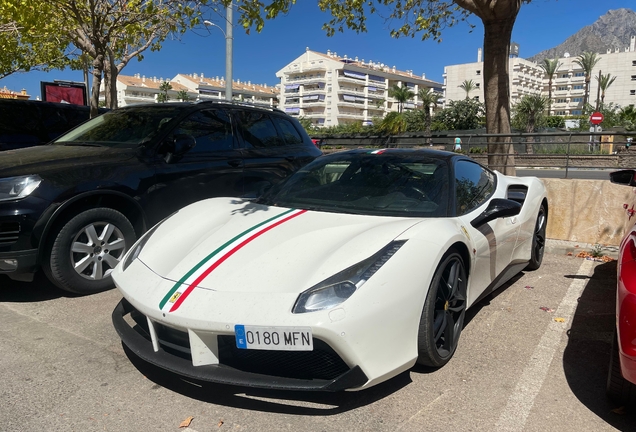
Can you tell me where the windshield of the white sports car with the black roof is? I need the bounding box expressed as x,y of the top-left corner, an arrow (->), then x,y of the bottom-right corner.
263,152 -> 449,217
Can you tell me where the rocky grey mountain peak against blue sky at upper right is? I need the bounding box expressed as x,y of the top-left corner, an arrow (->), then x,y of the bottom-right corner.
528,8 -> 636,63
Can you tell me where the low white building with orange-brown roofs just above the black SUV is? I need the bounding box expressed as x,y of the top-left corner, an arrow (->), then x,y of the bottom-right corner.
111,74 -> 278,107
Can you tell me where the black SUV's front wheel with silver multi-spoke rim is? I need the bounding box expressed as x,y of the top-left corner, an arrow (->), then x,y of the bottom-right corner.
44,207 -> 136,294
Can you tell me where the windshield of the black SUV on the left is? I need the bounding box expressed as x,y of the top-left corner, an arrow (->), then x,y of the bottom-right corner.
54,106 -> 183,147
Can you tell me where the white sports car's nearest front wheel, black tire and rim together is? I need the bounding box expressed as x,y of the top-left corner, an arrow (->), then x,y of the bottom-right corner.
417,250 -> 468,368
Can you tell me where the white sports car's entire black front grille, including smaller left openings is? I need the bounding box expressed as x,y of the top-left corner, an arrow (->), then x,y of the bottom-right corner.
131,310 -> 349,380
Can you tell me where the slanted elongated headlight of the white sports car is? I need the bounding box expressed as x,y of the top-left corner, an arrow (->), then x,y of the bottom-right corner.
292,240 -> 406,313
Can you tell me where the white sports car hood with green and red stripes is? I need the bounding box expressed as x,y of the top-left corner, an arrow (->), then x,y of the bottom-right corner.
139,198 -> 422,293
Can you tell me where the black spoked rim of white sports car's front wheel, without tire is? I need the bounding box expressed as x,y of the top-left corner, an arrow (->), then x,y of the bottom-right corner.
433,257 -> 466,358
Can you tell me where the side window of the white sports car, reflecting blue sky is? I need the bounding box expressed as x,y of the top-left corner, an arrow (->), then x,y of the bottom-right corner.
455,160 -> 495,216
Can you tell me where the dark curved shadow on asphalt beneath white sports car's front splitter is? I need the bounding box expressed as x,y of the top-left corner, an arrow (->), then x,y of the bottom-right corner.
122,344 -> 411,416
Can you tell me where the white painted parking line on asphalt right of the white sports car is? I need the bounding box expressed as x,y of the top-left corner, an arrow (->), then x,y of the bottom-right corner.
495,260 -> 594,432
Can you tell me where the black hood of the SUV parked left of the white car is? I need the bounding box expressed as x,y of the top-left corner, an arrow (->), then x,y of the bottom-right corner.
0,141 -> 136,177
